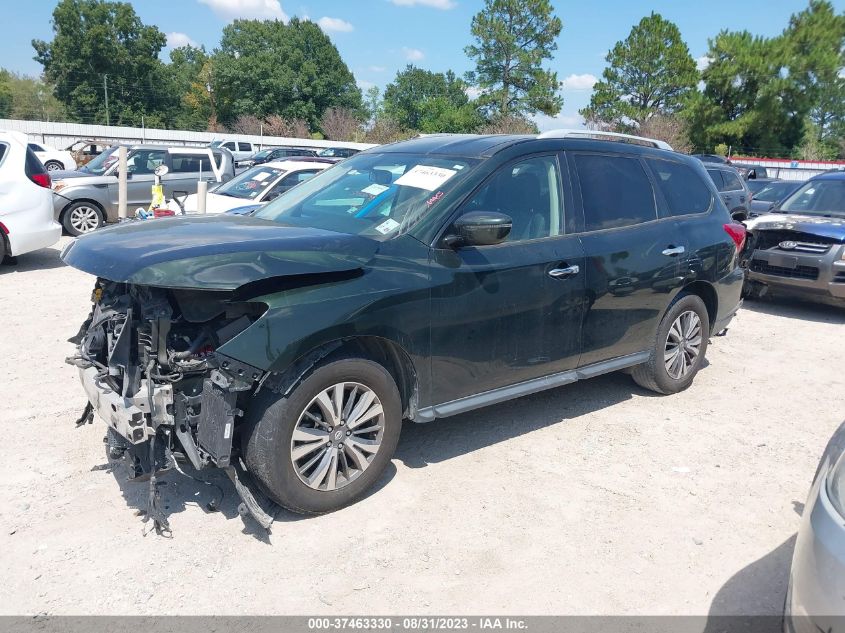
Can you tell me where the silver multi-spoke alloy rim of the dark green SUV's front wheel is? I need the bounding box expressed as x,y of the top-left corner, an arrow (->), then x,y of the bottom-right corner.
290,382 -> 384,491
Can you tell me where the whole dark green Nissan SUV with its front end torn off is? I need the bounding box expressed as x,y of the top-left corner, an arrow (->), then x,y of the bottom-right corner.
63,131 -> 745,524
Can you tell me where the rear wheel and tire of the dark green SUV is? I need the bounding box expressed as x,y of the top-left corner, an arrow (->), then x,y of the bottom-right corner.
632,294 -> 710,395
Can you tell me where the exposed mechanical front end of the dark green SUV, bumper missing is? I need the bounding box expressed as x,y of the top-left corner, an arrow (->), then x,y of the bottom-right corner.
68,279 -> 269,531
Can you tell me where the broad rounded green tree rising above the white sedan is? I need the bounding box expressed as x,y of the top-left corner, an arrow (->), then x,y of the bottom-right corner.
213,18 -> 363,128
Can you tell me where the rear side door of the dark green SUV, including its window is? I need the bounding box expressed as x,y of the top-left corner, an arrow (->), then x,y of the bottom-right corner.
570,152 -> 685,366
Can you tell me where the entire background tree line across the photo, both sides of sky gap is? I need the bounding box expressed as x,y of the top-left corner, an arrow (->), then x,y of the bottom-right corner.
0,0 -> 845,159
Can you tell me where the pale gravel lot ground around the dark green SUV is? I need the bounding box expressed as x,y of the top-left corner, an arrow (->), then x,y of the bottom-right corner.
0,238 -> 845,614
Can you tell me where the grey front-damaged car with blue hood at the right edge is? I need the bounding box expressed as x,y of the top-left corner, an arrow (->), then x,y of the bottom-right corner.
744,172 -> 845,305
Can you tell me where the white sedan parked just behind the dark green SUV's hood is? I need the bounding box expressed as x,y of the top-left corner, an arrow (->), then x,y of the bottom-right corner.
167,160 -> 333,213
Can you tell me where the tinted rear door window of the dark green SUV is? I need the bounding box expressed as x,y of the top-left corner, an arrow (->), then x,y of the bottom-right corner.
575,154 -> 657,231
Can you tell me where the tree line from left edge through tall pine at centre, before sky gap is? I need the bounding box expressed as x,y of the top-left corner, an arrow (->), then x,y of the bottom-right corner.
0,0 -> 562,142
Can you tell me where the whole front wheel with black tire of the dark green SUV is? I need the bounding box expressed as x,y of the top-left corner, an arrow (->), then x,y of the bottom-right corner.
241,359 -> 402,514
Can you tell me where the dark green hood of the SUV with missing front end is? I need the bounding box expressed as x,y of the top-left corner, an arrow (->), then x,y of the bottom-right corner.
62,215 -> 379,290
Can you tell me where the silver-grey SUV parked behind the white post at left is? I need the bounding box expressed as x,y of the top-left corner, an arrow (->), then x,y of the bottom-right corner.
53,145 -> 235,235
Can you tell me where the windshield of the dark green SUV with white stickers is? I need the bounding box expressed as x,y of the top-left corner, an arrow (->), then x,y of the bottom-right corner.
255,153 -> 478,239
